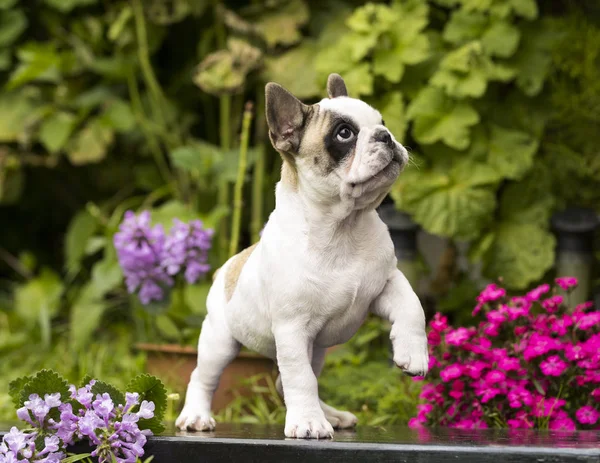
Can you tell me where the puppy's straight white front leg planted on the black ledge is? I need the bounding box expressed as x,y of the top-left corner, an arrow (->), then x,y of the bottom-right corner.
274,323 -> 333,439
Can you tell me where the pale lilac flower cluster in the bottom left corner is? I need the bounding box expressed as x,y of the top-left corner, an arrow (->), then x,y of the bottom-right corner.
0,380 -> 154,463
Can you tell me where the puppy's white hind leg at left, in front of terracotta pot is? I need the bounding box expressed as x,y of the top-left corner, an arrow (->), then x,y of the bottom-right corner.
175,307 -> 240,431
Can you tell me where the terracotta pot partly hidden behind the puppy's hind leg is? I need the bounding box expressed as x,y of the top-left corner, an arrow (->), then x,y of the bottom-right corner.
135,344 -> 277,413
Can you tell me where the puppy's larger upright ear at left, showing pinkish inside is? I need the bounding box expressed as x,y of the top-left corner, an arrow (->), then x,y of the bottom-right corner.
265,82 -> 309,153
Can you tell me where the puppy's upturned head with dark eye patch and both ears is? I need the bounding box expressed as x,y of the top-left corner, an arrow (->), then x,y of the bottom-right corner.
266,74 -> 408,210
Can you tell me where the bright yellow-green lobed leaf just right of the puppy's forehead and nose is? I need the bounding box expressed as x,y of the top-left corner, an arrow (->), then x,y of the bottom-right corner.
407,87 -> 479,150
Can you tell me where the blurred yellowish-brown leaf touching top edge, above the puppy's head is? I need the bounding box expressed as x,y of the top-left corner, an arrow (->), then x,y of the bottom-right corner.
254,0 -> 309,48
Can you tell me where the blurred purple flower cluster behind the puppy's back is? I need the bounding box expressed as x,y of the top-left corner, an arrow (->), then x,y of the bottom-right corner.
114,211 -> 213,304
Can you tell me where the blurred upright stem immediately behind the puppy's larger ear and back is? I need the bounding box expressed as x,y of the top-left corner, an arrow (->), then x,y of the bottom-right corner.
250,88 -> 265,243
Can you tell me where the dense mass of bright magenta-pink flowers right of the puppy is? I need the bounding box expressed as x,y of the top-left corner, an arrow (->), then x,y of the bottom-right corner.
409,278 -> 600,430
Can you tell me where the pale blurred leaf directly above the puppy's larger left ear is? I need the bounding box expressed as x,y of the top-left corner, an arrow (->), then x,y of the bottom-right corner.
264,39 -> 323,99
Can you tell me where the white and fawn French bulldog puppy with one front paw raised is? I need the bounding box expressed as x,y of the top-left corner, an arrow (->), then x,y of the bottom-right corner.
176,74 -> 429,439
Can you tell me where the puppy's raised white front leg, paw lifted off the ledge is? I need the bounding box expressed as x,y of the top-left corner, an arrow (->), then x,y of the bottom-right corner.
371,269 -> 429,376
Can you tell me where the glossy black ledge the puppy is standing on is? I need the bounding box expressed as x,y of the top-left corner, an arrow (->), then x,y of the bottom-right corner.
0,424 -> 600,463
